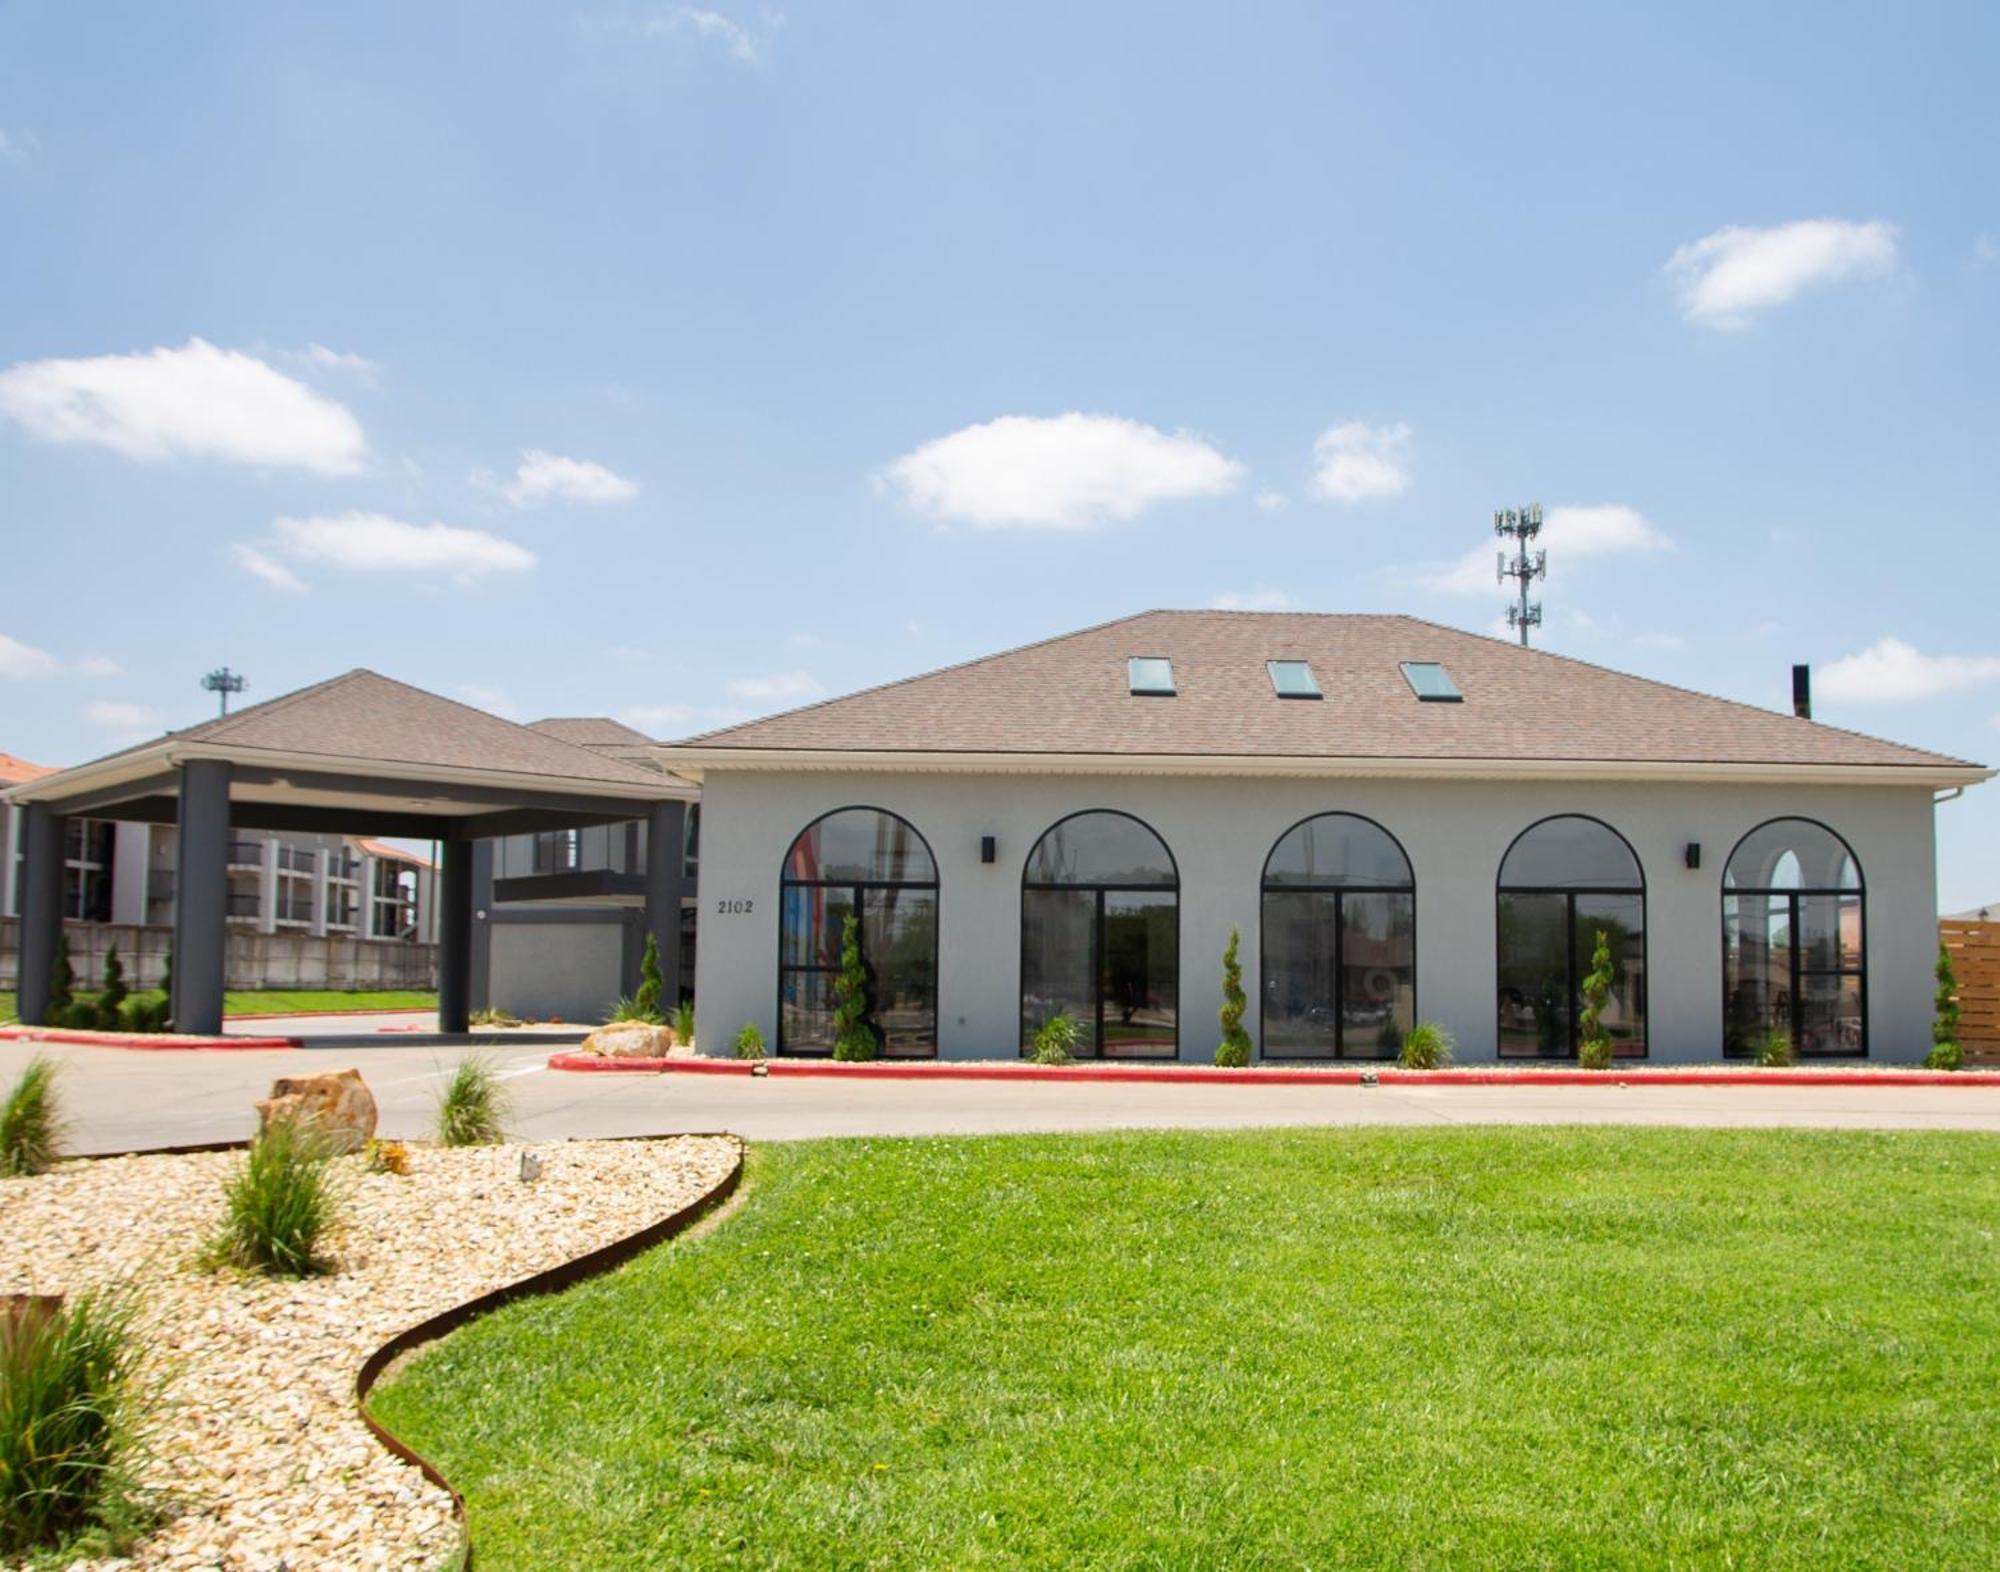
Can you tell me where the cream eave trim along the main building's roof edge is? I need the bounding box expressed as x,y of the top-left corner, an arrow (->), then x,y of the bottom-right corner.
654,746 -> 2000,786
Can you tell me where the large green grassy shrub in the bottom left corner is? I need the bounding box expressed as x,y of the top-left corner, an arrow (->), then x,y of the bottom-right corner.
0,1288 -> 144,1558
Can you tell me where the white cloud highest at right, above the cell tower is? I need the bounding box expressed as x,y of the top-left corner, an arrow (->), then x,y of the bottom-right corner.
1666,218 -> 1896,328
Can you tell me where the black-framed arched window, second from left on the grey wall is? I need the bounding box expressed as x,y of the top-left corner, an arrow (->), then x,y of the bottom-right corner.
1020,812 -> 1180,1058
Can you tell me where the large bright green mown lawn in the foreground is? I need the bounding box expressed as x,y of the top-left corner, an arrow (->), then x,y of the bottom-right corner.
376,1128 -> 2000,1568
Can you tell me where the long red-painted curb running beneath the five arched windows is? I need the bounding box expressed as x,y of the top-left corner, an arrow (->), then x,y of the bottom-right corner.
548,1054 -> 2000,1088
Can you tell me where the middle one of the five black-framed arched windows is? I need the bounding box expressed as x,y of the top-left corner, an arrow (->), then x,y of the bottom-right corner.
1260,814 -> 1416,1058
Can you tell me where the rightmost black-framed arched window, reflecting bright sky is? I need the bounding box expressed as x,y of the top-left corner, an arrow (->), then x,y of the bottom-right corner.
1722,818 -> 1868,1056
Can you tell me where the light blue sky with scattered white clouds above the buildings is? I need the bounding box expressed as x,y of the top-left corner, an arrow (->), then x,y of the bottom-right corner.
0,0 -> 2000,906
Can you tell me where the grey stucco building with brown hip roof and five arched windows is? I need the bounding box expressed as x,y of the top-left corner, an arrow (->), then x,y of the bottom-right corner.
658,612 -> 1992,1062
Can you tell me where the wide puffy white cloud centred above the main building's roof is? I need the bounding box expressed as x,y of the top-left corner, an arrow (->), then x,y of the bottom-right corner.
878,410 -> 1244,530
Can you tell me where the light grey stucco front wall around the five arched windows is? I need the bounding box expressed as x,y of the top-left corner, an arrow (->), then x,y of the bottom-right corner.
688,770 -> 1938,1064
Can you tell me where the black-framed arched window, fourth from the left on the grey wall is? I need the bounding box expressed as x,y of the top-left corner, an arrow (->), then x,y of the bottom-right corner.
1498,814 -> 1646,1058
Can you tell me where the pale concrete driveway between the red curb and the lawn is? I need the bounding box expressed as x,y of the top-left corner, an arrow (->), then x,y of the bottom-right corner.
11,1022 -> 2000,1152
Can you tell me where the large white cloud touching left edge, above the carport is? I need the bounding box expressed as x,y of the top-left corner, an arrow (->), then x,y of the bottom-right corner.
0,338 -> 366,474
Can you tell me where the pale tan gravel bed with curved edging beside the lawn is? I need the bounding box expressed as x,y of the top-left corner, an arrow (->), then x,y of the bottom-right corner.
0,1136 -> 738,1572
